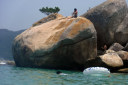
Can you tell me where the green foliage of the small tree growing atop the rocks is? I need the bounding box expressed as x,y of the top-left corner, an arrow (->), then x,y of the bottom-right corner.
39,7 -> 60,15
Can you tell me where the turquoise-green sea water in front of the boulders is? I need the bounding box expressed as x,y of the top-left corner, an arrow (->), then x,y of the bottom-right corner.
0,64 -> 128,85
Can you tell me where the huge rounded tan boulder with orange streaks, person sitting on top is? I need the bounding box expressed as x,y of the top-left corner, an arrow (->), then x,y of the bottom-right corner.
12,17 -> 97,70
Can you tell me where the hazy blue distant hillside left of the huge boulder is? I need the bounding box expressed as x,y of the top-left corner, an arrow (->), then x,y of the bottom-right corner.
0,29 -> 24,60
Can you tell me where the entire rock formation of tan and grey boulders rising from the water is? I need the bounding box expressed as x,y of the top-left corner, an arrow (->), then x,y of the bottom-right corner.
12,0 -> 128,72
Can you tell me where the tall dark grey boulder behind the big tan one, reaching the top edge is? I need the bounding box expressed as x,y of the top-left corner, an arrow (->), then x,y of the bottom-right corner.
81,0 -> 128,49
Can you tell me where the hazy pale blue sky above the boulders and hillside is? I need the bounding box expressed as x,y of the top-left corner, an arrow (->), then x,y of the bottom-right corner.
0,0 -> 128,31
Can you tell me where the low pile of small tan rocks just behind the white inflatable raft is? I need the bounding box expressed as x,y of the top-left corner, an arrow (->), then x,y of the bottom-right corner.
85,49 -> 128,72
